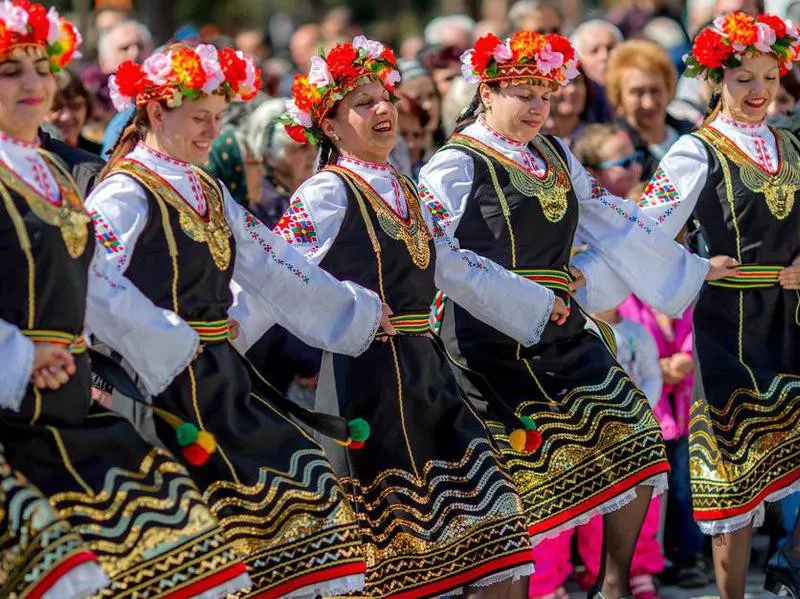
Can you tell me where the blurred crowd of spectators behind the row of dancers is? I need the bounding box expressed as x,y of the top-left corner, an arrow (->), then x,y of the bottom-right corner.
48,0 -> 800,599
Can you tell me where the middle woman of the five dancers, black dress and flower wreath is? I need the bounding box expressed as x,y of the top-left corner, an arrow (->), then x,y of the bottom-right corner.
275,36 -> 558,599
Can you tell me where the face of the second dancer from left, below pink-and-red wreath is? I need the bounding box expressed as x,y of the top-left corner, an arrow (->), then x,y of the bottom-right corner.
147,94 -> 225,164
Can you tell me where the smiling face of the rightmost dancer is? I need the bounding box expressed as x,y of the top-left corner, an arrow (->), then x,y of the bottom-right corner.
722,54 -> 780,124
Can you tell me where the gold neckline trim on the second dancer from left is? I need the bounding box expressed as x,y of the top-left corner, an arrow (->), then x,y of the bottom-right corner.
112,160 -> 231,270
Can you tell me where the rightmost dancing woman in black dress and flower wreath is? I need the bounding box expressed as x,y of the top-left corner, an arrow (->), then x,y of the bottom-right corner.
592,12 -> 800,598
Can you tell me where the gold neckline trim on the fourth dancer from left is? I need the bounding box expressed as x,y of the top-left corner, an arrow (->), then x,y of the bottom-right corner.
448,134 -> 572,223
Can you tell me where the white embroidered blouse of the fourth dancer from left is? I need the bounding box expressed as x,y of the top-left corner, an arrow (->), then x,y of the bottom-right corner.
420,119 -> 709,314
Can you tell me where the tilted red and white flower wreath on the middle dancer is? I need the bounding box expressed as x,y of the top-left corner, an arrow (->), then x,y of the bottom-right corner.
281,35 -> 400,144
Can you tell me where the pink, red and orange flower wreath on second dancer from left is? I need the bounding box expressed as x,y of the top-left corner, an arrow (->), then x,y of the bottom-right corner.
108,44 -> 261,111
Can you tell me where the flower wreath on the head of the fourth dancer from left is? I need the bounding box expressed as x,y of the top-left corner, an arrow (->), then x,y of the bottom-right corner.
461,31 -> 578,89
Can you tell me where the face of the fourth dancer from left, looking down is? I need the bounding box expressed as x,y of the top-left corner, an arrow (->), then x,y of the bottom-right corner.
480,83 -> 553,143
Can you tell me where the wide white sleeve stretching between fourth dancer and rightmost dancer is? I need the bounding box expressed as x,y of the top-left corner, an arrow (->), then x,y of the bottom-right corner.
565,142 -> 709,315
